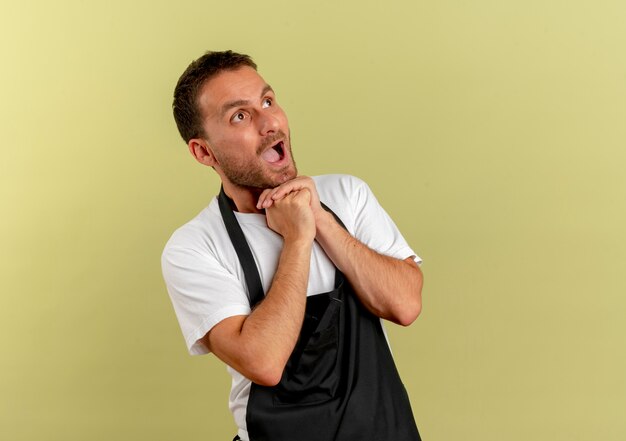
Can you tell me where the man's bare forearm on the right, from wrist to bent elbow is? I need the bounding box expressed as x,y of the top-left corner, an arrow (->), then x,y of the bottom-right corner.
316,208 -> 422,326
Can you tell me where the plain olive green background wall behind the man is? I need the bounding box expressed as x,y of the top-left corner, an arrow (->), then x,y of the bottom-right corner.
0,0 -> 626,441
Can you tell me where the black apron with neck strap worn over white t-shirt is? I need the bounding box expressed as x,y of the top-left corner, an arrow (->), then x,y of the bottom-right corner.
218,189 -> 421,441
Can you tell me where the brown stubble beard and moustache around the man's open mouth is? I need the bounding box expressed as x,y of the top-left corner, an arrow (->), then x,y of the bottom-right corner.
219,130 -> 298,190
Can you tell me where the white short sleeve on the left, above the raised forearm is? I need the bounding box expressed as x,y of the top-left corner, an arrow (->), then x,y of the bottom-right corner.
161,244 -> 250,355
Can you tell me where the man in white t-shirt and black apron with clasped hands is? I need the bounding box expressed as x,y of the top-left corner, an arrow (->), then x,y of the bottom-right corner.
162,51 -> 422,441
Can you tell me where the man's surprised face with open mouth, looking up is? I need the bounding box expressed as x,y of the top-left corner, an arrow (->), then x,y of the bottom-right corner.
199,66 -> 297,189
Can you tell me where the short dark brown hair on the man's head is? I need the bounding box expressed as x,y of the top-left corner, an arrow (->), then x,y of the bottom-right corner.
172,51 -> 256,143
